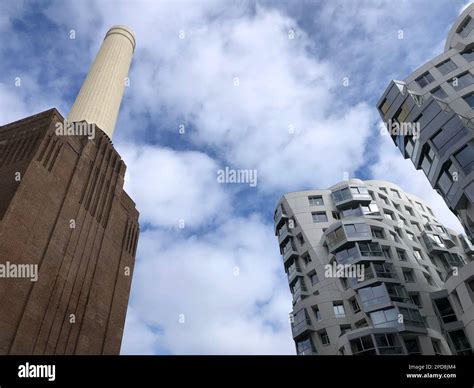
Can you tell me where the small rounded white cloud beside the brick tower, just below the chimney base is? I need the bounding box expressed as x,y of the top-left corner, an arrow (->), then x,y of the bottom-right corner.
119,145 -> 232,227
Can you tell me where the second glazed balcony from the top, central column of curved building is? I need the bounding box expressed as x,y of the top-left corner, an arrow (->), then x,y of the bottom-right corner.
324,220 -> 372,253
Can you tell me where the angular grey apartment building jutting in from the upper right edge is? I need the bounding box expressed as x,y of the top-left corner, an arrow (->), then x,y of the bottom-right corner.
377,4 -> 474,239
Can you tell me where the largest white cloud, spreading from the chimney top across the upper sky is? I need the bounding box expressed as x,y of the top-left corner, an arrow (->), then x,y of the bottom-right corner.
60,2 -> 374,192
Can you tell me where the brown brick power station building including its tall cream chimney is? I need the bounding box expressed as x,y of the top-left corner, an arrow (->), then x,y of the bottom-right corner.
0,26 -> 139,355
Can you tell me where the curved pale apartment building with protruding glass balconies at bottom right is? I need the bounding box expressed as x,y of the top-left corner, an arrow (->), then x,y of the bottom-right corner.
274,179 -> 474,355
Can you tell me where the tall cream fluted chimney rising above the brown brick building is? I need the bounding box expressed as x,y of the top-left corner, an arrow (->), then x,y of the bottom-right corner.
67,26 -> 135,139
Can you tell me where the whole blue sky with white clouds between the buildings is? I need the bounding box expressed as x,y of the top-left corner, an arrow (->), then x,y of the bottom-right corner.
0,0 -> 469,354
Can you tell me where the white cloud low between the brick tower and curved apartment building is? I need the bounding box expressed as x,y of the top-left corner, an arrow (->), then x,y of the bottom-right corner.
122,215 -> 294,354
